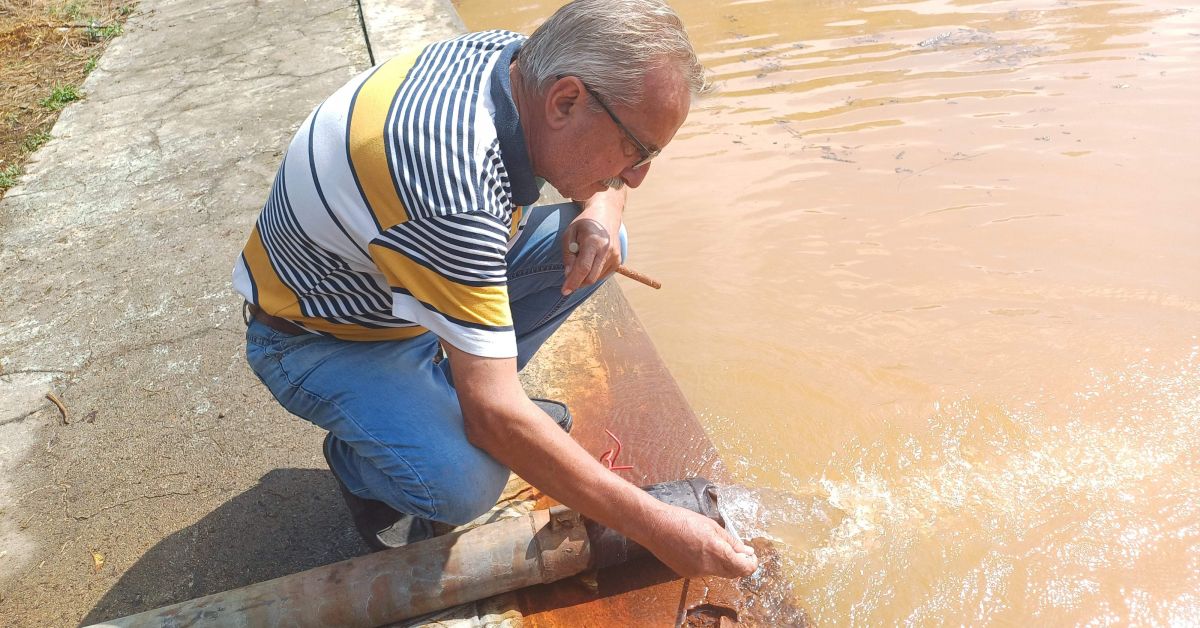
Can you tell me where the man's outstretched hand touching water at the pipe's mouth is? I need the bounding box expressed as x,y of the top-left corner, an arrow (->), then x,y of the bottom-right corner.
635,504 -> 758,578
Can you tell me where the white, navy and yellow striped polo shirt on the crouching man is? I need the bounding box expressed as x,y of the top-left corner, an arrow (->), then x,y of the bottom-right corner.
233,31 -> 539,358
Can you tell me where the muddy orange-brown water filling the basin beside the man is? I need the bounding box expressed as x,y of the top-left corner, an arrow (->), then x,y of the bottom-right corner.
456,0 -> 1200,626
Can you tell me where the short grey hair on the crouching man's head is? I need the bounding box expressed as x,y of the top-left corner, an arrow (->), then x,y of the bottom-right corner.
517,0 -> 709,106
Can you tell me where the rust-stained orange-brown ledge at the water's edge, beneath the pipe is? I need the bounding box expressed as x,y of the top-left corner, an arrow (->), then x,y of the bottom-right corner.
517,285 -> 742,628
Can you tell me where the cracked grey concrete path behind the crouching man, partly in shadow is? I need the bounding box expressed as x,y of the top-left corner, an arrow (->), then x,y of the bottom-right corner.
0,0 -> 472,626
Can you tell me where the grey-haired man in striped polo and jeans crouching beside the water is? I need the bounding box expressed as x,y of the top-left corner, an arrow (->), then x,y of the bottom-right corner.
234,0 -> 756,576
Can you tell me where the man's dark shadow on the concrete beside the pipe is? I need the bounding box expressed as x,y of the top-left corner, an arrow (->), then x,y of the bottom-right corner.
83,468 -> 368,626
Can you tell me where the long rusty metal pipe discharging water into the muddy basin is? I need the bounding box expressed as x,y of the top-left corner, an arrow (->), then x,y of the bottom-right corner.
88,478 -> 721,628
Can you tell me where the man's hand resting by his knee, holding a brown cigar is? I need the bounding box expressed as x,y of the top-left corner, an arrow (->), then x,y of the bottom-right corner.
562,190 -> 625,295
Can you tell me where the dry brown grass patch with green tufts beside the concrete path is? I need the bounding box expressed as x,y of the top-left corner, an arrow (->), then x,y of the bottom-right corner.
0,0 -> 134,195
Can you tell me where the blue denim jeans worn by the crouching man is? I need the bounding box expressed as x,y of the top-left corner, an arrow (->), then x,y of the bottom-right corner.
246,203 -> 626,525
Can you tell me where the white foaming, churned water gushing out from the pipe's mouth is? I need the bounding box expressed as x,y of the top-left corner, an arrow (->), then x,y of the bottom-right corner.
720,348 -> 1200,624
